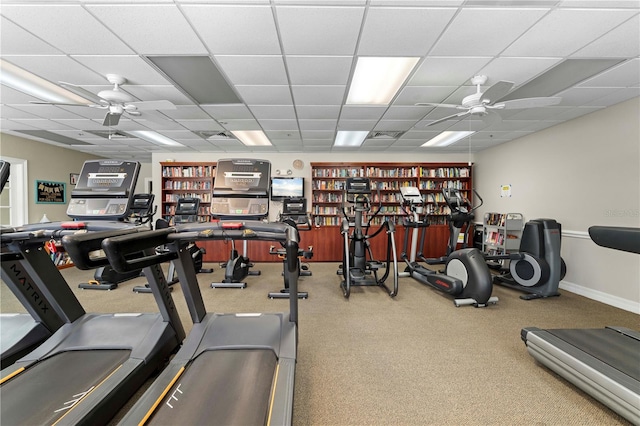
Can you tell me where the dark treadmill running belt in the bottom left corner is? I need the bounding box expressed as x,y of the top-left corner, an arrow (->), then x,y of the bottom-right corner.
0,350 -> 131,425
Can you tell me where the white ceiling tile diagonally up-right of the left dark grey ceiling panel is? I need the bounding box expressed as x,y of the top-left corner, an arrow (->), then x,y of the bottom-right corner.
182,5 -> 282,55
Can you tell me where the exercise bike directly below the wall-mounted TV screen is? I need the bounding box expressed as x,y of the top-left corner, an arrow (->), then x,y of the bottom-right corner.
269,198 -> 313,299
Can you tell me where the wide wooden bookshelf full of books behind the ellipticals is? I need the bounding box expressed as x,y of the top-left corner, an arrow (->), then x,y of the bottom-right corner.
311,163 -> 472,226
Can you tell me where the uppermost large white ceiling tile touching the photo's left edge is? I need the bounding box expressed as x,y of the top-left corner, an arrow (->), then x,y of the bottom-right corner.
2,3 -> 137,54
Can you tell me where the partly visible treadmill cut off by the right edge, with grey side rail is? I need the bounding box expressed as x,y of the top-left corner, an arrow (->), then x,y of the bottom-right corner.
521,226 -> 640,424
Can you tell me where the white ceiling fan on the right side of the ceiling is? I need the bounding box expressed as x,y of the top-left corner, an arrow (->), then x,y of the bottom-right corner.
416,75 -> 562,126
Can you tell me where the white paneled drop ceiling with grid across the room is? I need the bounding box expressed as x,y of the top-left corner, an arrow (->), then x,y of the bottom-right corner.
0,0 -> 640,161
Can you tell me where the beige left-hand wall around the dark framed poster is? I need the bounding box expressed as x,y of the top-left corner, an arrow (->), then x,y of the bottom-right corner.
0,133 -> 151,223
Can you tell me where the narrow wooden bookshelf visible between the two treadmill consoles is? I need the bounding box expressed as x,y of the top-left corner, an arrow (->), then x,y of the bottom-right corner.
160,162 -> 216,224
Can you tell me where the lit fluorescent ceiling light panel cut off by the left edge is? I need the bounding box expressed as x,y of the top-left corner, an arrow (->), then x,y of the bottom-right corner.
0,59 -> 91,104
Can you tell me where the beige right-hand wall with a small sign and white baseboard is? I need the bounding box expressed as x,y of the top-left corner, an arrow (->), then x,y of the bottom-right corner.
474,98 -> 640,312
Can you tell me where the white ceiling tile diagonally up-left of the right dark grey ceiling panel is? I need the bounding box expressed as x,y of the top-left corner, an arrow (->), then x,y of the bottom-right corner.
502,9 -> 634,56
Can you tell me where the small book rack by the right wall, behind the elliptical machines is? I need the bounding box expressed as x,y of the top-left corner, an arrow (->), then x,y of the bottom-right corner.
482,212 -> 524,255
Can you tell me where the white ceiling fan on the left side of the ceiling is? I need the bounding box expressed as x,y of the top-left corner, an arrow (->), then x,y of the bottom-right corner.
32,74 -> 176,126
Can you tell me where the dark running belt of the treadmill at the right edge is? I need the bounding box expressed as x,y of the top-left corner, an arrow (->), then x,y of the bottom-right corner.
546,328 -> 640,381
